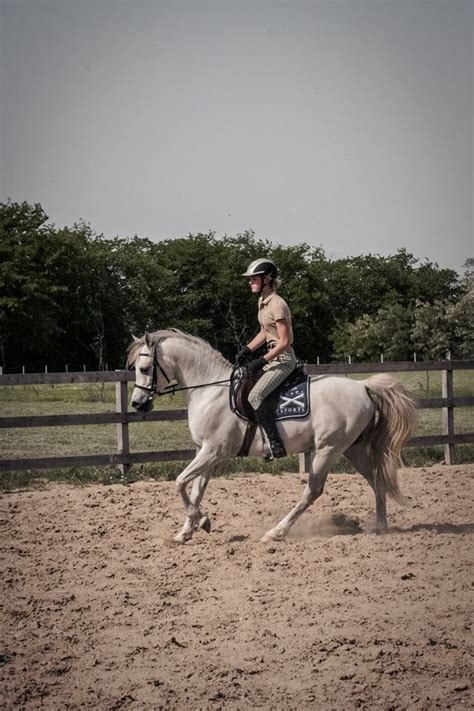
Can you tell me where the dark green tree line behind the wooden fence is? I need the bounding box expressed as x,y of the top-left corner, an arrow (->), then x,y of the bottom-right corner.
0,201 -> 474,372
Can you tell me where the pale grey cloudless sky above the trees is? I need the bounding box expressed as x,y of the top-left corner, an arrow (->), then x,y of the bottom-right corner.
0,0 -> 474,270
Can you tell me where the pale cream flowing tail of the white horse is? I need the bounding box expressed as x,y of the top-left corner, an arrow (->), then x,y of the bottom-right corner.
364,373 -> 418,503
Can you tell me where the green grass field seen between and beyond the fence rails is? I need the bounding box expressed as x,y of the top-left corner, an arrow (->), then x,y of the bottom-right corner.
0,371 -> 474,489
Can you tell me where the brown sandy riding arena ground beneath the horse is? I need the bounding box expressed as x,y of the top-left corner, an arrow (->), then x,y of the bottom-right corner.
0,465 -> 474,710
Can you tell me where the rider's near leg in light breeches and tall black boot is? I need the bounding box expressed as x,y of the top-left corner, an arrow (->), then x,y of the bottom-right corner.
248,352 -> 296,459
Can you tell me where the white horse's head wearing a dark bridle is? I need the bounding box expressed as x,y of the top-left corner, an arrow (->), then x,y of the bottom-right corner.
127,332 -> 170,412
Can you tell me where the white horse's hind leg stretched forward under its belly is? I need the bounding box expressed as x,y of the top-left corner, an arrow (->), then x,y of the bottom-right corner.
262,446 -> 342,542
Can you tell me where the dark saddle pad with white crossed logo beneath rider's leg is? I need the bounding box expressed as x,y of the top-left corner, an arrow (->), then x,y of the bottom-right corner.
230,368 -> 310,420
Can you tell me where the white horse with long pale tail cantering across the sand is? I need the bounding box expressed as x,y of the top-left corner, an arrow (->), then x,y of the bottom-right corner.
127,330 -> 416,543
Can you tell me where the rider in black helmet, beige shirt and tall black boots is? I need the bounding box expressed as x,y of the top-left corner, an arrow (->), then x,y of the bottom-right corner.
237,258 -> 296,459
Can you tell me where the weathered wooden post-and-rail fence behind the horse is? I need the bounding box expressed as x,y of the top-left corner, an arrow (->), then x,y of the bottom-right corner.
0,360 -> 474,471
